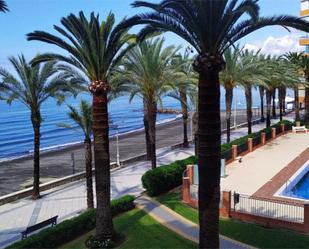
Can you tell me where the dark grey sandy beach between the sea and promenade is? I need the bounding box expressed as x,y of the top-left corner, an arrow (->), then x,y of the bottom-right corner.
0,110 -> 258,196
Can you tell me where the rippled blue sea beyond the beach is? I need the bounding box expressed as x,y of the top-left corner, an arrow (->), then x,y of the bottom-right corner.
0,88 -> 290,162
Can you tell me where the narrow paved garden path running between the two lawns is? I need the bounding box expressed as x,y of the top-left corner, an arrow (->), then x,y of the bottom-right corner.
135,196 -> 252,249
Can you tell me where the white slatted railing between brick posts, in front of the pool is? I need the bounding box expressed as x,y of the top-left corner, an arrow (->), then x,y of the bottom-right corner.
231,193 -> 304,223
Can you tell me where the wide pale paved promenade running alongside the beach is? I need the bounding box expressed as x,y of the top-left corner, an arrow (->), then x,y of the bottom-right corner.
0,117 -> 288,248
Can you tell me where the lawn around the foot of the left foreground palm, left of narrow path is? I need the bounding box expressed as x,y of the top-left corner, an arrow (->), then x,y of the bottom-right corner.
61,209 -> 197,249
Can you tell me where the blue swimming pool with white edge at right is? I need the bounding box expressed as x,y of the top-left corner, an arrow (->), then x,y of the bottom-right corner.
275,160 -> 309,200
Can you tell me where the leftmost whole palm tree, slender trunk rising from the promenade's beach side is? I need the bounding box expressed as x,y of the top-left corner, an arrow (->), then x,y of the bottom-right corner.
0,55 -> 73,199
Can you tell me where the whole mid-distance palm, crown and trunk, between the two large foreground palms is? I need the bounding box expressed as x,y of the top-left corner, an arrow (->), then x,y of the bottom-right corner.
119,38 -> 179,168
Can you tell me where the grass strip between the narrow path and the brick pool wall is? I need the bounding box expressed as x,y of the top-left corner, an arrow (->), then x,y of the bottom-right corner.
157,189 -> 309,248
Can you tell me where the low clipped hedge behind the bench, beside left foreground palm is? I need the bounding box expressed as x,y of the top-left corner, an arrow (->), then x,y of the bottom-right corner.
7,195 -> 135,249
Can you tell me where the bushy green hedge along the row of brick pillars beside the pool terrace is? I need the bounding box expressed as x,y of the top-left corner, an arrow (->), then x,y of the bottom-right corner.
142,120 -> 293,196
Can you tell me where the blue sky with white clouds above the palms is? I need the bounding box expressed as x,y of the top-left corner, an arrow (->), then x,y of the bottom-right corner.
0,0 -> 302,67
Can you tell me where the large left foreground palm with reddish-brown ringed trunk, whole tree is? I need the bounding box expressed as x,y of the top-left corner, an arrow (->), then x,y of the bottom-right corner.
27,12 -> 134,242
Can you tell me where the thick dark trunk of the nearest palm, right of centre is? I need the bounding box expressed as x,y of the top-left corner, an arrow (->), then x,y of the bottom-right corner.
198,66 -> 221,248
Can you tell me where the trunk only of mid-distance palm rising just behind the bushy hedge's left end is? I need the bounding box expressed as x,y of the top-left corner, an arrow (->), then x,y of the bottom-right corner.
147,102 -> 157,169
